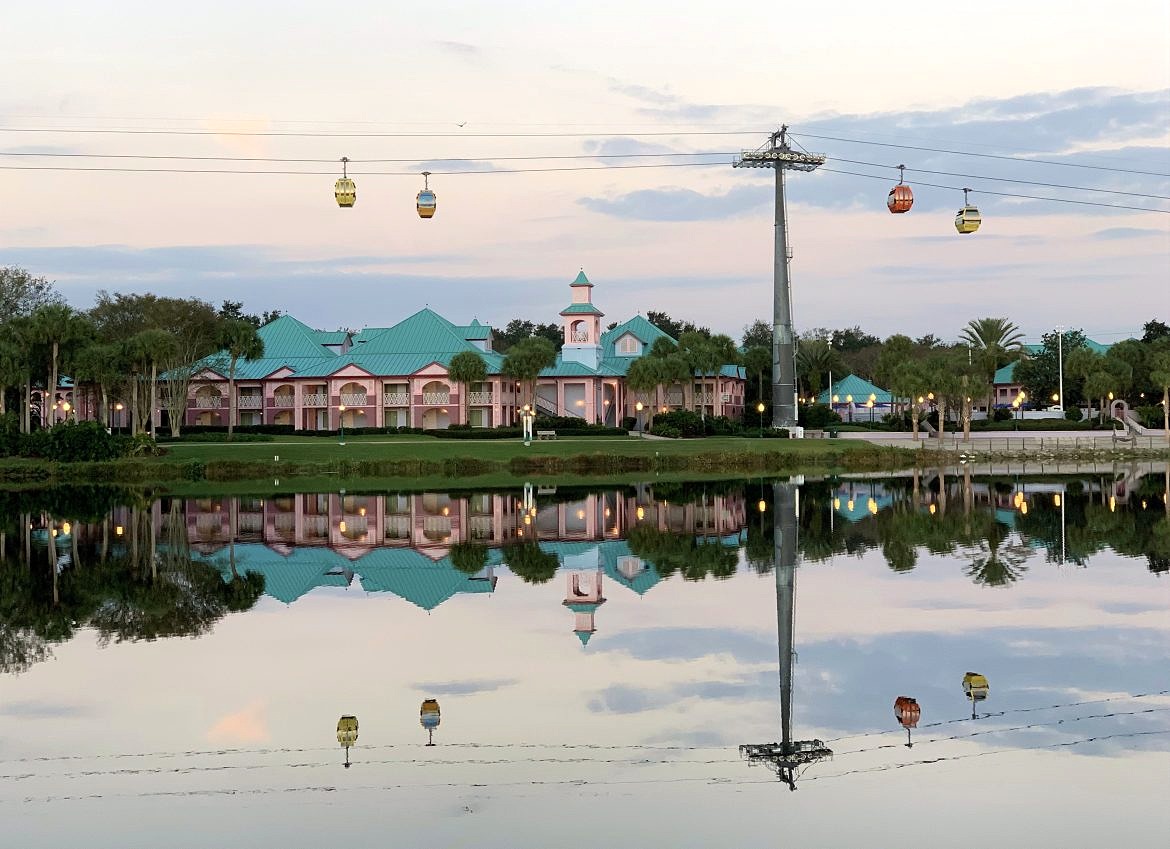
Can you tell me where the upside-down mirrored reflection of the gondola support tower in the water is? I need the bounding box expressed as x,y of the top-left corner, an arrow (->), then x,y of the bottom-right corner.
739,483 -> 833,791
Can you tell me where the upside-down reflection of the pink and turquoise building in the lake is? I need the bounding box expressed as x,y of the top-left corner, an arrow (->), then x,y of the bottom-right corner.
153,484 -> 745,646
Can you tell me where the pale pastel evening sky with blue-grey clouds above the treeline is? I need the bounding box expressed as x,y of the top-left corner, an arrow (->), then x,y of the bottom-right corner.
0,0 -> 1170,343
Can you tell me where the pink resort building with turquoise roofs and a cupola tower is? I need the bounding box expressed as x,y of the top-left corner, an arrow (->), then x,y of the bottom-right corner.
186,271 -> 745,430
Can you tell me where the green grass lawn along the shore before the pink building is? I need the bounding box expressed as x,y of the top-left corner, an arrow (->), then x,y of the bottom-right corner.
0,435 -> 914,491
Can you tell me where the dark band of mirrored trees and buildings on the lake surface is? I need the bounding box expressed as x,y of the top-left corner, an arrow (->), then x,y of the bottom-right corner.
0,467 -> 1170,672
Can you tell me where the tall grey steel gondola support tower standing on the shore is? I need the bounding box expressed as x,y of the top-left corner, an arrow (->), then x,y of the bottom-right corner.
731,124 -> 832,432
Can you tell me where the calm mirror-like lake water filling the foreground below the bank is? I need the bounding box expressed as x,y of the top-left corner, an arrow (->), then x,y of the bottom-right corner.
0,469 -> 1170,848
